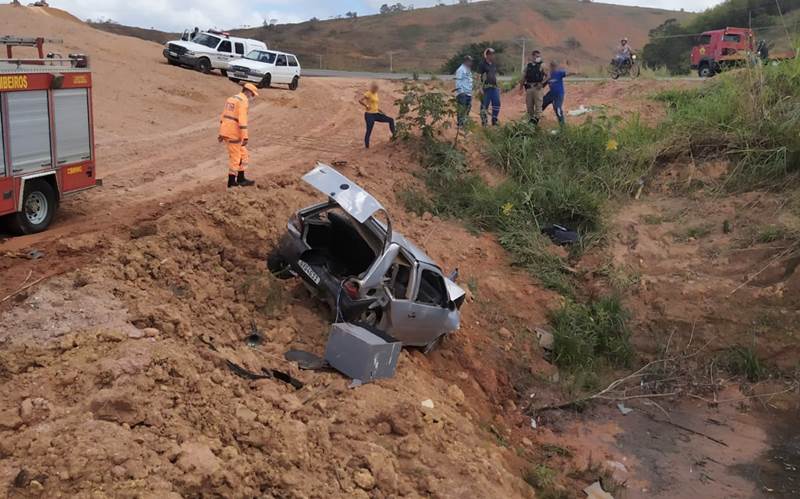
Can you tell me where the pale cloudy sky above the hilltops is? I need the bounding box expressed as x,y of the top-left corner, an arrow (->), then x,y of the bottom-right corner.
59,0 -> 721,31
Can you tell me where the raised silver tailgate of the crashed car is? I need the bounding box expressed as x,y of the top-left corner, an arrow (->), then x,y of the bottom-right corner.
303,163 -> 386,224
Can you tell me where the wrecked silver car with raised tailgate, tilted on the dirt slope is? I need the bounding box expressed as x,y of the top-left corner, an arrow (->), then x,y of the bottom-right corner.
267,164 -> 465,348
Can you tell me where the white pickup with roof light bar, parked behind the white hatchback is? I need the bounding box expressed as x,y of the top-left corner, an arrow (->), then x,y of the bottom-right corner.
164,31 -> 267,76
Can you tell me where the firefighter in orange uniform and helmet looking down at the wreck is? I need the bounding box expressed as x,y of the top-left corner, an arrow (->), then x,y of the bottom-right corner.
218,83 -> 258,187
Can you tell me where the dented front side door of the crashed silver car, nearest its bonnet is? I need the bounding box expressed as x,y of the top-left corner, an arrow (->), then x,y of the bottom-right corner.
388,265 -> 450,346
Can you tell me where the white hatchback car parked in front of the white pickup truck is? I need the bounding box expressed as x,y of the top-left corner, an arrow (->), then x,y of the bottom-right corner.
228,49 -> 300,90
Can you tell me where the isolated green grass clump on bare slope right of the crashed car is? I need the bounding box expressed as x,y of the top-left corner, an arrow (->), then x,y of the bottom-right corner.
550,296 -> 633,371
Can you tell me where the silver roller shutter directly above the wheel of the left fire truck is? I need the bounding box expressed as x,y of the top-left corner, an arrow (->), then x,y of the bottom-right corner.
7,90 -> 53,176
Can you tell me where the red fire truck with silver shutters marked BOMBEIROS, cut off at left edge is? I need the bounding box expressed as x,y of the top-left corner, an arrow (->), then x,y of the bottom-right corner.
0,36 -> 97,234
